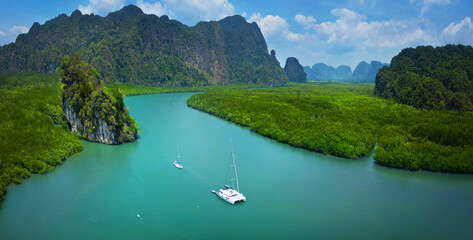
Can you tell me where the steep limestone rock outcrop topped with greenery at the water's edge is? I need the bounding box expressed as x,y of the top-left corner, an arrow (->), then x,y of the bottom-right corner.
57,55 -> 138,144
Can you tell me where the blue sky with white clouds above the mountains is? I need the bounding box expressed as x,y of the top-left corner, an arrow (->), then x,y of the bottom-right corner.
0,0 -> 473,69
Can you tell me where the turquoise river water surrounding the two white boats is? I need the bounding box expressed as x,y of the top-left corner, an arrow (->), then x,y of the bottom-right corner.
0,93 -> 473,239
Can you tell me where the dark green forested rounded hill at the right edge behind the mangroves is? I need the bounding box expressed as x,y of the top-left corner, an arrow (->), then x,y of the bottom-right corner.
374,45 -> 473,111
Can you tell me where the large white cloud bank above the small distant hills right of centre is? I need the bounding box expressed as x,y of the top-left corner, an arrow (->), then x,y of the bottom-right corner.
249,8 -> 440,68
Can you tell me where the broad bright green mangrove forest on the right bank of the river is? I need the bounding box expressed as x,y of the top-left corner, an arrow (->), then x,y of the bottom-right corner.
187,83 -> 473,173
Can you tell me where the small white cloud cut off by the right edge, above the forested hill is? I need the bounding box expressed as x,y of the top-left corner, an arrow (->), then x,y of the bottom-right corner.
440,17 -> 473,44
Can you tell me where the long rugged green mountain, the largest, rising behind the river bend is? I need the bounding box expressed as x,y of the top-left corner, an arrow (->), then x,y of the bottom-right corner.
0,5 -> 287,86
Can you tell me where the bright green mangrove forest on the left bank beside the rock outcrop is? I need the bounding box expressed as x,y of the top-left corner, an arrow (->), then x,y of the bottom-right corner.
0,73 -> 82,200
